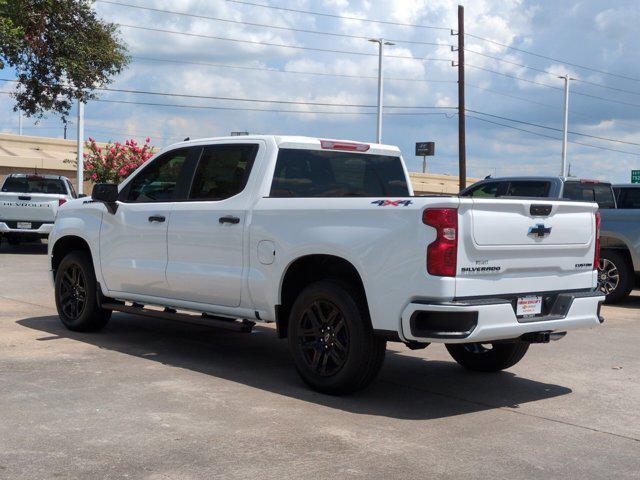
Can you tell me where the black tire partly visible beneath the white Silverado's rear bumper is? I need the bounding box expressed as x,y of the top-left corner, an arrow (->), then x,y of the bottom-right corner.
445,342 -> 529,372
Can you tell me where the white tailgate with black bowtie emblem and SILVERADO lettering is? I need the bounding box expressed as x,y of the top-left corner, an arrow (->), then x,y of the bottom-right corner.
456,198 -> 598,298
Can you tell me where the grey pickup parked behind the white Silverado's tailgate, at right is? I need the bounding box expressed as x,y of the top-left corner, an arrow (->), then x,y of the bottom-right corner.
460,177 -> 640,303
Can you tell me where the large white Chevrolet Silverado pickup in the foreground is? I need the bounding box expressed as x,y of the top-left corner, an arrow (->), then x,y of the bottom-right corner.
49,136 -> 604,394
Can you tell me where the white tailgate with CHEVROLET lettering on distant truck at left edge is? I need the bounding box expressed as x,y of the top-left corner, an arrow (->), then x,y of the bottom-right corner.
0,193 -> 58,222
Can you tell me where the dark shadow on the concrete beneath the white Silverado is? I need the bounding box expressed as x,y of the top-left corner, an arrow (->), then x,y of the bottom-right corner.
17,314 -> 571,419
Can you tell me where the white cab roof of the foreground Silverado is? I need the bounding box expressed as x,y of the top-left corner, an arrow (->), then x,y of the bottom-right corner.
165,135 -> 400,155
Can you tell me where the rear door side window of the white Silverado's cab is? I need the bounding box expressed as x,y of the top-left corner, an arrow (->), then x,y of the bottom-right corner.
189,143 -> 258,200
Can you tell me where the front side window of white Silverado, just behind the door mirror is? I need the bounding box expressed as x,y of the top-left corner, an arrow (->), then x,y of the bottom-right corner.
126,149 -> 189,203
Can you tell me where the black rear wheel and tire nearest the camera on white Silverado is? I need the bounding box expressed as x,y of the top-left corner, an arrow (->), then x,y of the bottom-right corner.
288,280 -> 387,395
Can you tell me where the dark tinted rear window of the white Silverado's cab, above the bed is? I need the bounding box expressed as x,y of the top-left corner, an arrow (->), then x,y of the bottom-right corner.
271,149 -> 409,197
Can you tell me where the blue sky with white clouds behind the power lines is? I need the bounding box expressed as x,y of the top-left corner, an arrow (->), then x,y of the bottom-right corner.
0,0 -> 640,182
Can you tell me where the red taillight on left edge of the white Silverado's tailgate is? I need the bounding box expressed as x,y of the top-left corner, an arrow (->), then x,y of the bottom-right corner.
422,208 -> 458,277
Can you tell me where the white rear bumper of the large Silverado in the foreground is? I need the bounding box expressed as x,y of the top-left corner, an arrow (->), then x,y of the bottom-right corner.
402,292 -> 604,343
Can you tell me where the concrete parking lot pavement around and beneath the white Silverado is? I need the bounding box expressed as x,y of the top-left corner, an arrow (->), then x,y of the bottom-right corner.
0,243 -> 640,480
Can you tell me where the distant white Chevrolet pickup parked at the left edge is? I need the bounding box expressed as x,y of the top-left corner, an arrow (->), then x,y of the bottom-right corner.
0,173 -> 76,245
